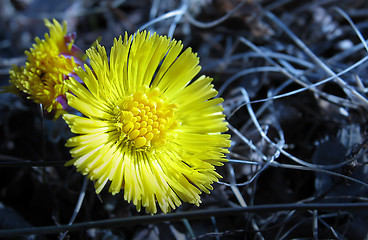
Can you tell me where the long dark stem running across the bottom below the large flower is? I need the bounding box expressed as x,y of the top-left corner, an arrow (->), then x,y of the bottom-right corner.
0,202 -> 368,237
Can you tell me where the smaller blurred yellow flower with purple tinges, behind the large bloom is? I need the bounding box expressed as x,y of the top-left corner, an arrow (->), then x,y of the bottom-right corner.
9,19 -> 81,118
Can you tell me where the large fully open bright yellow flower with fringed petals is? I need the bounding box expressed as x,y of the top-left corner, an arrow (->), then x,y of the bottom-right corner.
63,31 -> 230,214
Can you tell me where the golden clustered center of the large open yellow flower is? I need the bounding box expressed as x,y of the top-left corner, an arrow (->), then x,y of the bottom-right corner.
117,89 -> 179,148
